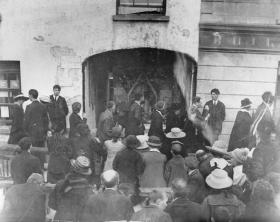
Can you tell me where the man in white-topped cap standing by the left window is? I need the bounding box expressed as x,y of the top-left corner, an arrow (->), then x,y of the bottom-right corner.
8,93 -> 28,144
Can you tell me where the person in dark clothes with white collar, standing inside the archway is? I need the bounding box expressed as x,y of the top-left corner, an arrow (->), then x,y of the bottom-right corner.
148,101 -> 165,141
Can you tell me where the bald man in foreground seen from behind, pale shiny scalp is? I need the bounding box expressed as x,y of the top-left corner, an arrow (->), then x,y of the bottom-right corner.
80,170 -> 133,222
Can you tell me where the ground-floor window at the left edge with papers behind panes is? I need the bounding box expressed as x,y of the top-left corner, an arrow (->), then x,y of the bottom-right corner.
0,61 -> 21,124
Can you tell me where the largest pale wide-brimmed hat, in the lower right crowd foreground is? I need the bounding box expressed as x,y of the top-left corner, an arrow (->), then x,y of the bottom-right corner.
205,169 -> 233,190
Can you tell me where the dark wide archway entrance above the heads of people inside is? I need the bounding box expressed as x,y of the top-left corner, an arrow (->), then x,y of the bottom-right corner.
83,48 -> 196,128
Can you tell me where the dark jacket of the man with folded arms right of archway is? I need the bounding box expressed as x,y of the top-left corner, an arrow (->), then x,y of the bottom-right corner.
202,100 -> 226,134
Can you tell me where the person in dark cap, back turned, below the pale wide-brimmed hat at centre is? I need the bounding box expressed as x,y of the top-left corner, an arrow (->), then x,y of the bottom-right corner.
164,141 -> 188,187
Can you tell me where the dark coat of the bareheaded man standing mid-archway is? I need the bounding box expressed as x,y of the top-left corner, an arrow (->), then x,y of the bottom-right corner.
126,102 -> 145,135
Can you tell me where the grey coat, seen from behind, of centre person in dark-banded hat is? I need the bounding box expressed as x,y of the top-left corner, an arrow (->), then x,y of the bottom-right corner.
140,151 -> 166,188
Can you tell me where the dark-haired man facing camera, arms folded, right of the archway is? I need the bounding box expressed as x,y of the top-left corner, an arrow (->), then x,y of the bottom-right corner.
202,89 -> 226,143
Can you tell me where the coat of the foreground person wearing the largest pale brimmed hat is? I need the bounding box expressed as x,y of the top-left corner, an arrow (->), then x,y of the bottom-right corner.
202,192 -> 245,222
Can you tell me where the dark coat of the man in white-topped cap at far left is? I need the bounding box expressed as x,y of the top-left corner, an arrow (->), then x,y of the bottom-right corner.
8,104 -> 25,144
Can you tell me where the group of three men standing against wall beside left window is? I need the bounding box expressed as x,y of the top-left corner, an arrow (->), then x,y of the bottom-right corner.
8,85 -> 69,147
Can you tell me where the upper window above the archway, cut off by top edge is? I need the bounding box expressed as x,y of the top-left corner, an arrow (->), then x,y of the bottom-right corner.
117,0 -> 166,15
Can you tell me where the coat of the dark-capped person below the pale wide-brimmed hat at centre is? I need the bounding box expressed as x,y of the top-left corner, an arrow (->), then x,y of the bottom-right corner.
164,155 -> 188,187
